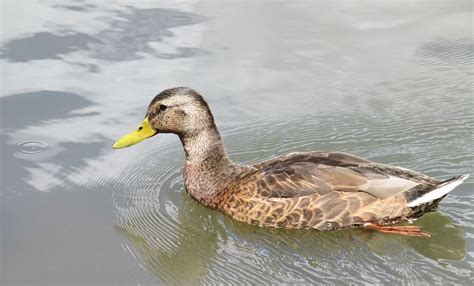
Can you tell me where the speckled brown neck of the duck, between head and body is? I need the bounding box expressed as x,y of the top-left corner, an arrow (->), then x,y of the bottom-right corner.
180,126 -> 239,207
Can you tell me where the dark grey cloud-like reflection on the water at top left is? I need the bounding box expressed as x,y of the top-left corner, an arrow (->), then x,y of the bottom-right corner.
0,5 -> 205,62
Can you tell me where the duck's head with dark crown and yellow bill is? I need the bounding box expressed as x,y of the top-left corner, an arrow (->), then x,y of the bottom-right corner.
112,87 -> 215,149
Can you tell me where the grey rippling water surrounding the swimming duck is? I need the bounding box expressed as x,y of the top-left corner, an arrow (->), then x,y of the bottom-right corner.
0,0 -> 474,285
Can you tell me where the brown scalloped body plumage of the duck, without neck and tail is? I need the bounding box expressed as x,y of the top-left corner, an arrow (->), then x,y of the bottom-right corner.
213,152 -> 438,230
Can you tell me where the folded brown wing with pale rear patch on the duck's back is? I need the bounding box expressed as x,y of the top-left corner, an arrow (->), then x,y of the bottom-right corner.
247,152 -> 438,199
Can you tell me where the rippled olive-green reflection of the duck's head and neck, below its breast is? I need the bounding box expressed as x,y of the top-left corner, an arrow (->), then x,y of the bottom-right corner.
115,194 -> 225,285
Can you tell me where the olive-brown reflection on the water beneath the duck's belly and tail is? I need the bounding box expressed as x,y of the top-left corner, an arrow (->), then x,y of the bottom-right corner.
228,212 -> 466,260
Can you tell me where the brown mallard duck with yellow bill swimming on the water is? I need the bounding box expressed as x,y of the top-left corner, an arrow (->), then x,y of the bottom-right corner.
113,87 -> 469,236
